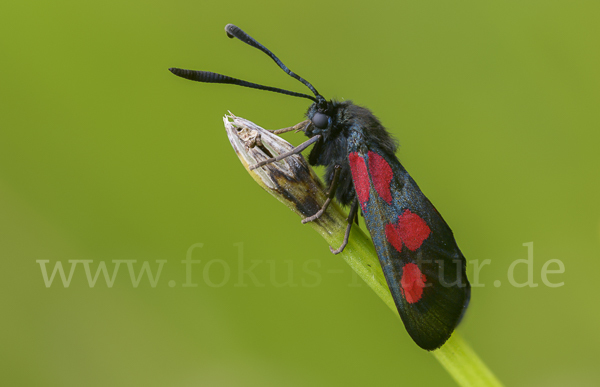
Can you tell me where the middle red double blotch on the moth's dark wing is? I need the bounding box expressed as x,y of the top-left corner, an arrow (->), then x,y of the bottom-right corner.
385,210 -> 431,252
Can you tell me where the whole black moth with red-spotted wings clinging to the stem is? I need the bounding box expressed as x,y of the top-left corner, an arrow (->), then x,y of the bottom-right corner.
169,24 -> 471,350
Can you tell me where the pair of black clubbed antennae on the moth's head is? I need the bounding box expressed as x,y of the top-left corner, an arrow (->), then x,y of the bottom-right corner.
169,24 -> 325,102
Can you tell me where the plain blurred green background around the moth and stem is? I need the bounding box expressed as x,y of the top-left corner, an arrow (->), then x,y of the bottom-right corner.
0,0 -> 600,386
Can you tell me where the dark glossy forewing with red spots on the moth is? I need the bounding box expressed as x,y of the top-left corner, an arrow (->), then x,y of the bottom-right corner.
348,142 -> 470,350
